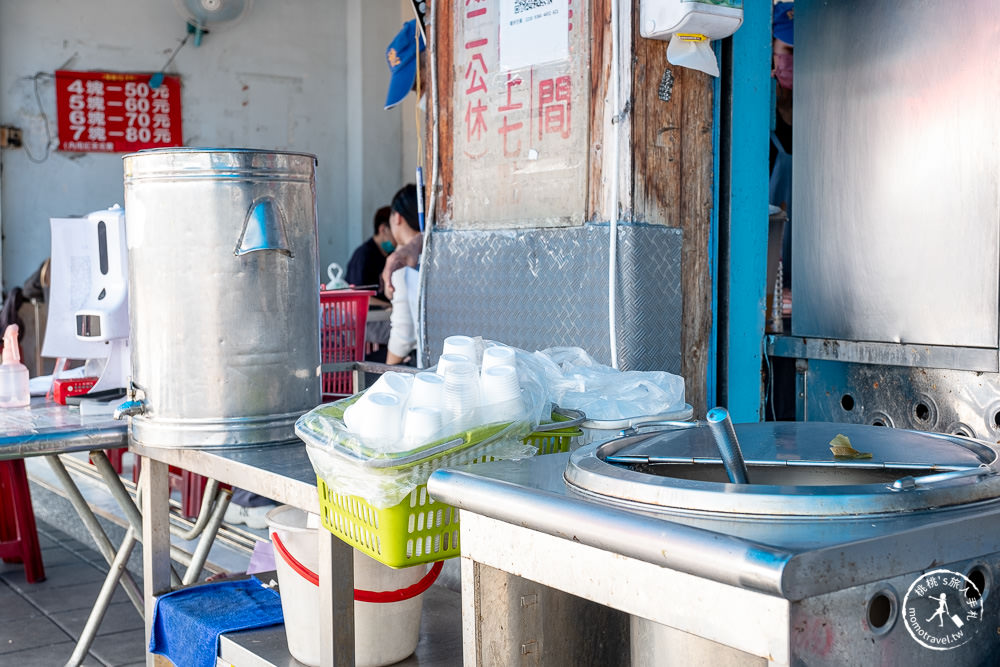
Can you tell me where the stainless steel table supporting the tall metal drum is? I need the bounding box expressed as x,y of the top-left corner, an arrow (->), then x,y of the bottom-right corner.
132,441 -> 354,667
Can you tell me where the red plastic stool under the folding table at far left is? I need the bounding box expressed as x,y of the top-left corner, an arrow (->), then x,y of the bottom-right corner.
0,461 -> 45,584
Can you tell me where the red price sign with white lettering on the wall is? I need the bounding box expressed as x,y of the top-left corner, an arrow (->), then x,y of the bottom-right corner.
56,70 -> 184,153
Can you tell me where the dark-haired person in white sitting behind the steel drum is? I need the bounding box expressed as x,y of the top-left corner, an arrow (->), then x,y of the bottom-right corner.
386,184 -> 420,364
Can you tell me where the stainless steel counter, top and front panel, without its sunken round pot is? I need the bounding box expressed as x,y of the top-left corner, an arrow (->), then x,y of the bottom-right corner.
427,452 -> 1000,665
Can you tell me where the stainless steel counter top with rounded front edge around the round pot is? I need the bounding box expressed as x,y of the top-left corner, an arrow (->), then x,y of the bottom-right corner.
428,454 -> 1000,600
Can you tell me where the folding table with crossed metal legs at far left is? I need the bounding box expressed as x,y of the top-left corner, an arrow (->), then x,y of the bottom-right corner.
0,398 -> 133,664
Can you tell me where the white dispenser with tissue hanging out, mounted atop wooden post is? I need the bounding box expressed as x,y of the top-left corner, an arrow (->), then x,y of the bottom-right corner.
639,0 -> 743,76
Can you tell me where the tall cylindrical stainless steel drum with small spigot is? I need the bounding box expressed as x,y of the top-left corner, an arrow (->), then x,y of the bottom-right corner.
118,148 -> 320,448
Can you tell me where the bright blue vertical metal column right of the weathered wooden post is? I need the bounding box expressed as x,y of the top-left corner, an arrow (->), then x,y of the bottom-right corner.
717,2 -> 772,422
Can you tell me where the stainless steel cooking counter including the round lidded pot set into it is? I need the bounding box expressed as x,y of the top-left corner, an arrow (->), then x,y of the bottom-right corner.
427,422 -> 1000,667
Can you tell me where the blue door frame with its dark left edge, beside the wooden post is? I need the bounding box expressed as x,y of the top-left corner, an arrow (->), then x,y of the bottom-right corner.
708,2 -> 772,422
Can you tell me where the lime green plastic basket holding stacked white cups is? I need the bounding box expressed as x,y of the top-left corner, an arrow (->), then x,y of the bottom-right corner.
316,412 -> 583,568
